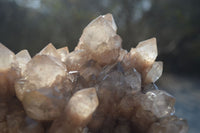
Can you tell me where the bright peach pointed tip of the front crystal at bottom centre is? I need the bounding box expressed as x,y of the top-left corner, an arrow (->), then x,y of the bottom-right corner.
65,88 -> 99,126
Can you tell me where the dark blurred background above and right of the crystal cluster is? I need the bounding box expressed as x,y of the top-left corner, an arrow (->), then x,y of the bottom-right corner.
0,0 -> 200,133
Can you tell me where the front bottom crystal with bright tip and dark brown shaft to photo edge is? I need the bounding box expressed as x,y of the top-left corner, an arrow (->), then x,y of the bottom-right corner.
50,88 -> 99,133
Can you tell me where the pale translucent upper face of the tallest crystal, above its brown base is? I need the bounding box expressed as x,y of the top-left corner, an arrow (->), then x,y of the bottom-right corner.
79,14 -> 116,50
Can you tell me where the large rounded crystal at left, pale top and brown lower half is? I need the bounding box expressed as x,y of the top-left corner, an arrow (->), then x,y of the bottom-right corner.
15,55 -> 66,120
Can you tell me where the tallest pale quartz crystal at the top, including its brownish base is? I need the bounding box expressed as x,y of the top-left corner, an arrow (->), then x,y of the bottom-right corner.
76,14 -> 121,65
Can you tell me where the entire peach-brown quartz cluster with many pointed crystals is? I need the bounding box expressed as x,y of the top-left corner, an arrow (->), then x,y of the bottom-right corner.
0,14 -> 188,133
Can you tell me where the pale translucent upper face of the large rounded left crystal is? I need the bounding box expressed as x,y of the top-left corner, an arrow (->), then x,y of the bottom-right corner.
24,55 -> 66,87
